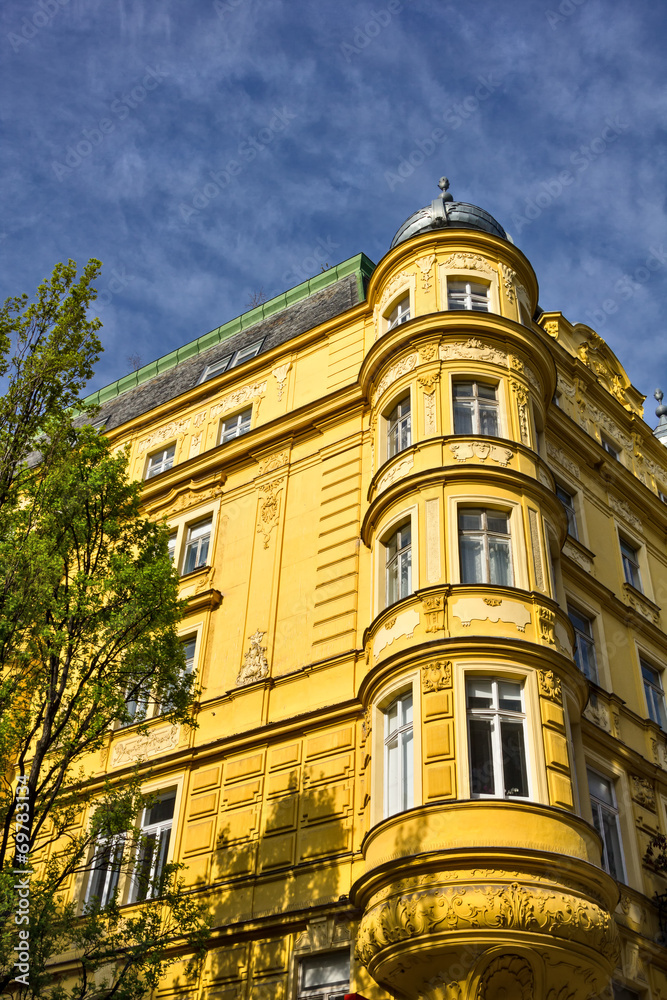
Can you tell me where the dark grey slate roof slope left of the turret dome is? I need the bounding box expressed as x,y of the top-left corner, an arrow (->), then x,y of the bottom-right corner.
94,274 -> 360,431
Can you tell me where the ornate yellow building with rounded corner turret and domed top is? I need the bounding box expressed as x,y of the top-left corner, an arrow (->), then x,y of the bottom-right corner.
85,179 -> 667,1000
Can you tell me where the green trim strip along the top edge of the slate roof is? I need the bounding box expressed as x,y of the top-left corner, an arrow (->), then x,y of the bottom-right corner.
84,253 -> 375,406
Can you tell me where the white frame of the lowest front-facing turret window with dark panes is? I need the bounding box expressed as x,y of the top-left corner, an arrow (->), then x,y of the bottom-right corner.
464,671 -> 532,802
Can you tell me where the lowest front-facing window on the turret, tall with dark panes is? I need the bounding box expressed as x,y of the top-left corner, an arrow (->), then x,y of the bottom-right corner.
466,677 -> 528,798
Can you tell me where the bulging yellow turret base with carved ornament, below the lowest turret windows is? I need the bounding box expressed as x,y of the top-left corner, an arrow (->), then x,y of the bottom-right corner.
352,800 -> 618,1000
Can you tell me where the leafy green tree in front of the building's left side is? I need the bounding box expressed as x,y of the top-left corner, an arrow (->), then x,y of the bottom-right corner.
0,261 -> 206,1000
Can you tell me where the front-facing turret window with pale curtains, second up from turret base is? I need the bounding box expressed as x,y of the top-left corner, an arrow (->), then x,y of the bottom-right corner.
459,507 -> 514,587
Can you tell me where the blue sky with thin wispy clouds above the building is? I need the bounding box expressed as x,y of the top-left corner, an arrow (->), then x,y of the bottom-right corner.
0,0 -> 667,425
